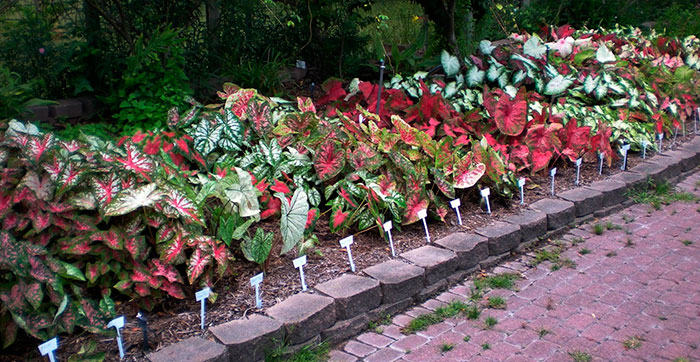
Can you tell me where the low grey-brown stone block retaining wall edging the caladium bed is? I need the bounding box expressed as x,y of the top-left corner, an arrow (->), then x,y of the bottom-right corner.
148,137 -> 700,362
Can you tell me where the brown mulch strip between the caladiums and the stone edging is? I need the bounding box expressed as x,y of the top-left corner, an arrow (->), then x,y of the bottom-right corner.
0,136 -> 692,361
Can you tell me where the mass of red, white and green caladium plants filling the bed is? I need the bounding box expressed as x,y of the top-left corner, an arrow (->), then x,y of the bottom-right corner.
0,22 -> 700,354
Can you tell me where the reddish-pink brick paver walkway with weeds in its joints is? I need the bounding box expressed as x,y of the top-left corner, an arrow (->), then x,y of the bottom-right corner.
331,173 -> 700,362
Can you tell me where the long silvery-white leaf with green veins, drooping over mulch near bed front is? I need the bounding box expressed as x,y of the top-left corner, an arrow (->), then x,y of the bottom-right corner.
275,188 -> 309,254
